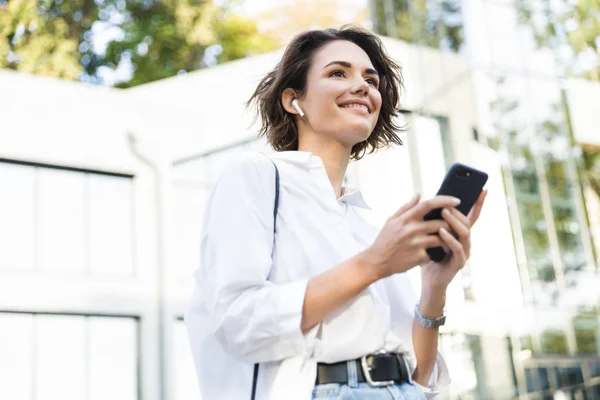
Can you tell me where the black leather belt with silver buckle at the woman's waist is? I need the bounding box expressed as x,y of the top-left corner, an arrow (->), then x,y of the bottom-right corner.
316,353 -> 412,386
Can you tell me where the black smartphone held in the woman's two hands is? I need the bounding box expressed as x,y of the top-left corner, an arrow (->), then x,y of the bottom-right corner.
424,163 -> 488,262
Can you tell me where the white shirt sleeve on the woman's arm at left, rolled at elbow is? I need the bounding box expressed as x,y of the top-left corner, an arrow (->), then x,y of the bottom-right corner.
192,155 -> 308,362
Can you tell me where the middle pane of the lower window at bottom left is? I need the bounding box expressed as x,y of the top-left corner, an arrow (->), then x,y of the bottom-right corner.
35,315 -> 86,400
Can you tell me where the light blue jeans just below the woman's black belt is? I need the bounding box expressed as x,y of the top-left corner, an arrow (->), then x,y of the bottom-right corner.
312,383 -> 425,400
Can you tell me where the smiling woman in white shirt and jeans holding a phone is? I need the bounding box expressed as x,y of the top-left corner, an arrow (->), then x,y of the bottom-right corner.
186,28 -> 485,400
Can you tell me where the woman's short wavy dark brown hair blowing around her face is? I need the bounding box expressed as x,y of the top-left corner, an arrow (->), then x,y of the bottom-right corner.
246,26 -> 405,160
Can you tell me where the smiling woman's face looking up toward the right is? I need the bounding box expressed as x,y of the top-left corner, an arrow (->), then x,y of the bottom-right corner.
299,40 -> 381,148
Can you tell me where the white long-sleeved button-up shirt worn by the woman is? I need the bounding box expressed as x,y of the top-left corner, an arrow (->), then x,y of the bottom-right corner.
185,151 -> 449,400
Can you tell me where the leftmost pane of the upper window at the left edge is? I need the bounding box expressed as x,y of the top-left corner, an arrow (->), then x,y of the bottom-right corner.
0,163 -> 35,269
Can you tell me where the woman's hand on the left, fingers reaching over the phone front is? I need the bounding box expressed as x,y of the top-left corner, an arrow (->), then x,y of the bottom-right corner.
364,195 -> 460,278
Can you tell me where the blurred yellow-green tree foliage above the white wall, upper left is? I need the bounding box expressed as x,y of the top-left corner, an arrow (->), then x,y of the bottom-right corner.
0,0 -> 280,87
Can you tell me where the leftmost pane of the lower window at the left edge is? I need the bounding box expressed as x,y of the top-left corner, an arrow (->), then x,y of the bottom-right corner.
0,314 -> 33,400
